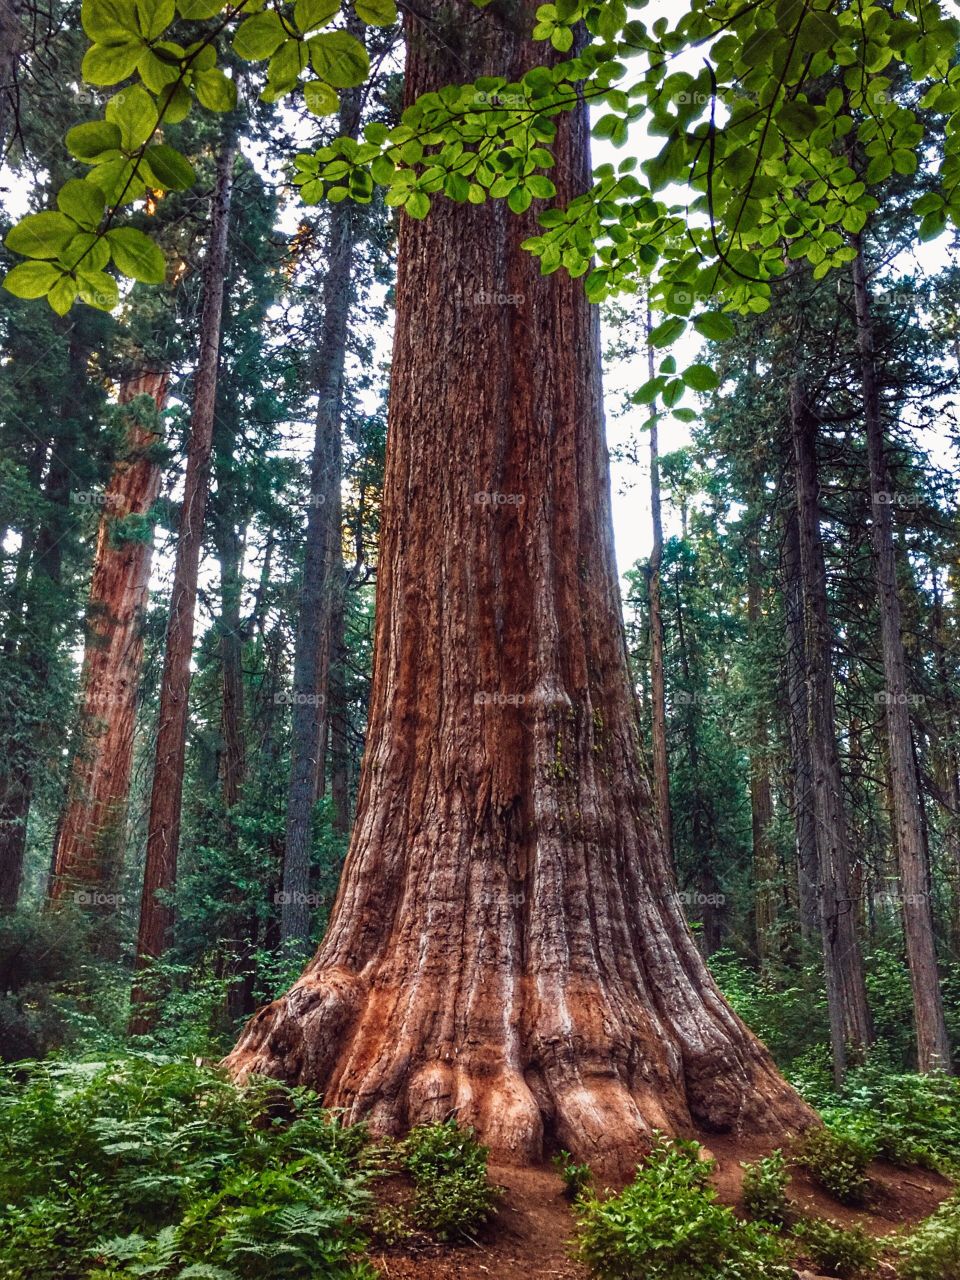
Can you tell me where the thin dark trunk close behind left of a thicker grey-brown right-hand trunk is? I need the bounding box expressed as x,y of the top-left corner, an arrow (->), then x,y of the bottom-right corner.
782,502 -> 820,942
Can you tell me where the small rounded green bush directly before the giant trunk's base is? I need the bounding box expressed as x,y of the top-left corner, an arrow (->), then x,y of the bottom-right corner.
402,1120 -> 500,1240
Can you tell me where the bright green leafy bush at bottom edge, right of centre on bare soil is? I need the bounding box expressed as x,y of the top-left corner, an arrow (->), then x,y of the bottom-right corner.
575,1138 -> 792,1280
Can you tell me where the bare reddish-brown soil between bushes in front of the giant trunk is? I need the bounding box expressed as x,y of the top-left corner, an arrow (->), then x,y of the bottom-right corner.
370,1135 -> 952,1280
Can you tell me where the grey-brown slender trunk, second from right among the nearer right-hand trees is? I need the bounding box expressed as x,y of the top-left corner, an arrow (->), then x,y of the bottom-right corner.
790,378 -> 872,1082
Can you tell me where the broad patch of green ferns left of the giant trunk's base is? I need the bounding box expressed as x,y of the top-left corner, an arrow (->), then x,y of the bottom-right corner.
0,1057 -> 372,1280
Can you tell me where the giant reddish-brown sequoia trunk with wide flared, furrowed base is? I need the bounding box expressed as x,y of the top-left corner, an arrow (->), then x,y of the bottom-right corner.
228,0 -> 810,1170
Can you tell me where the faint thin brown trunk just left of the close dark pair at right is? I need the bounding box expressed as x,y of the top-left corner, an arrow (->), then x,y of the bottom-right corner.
746,530 -> 777,960
